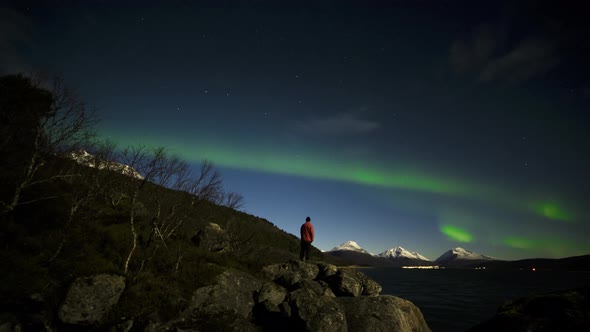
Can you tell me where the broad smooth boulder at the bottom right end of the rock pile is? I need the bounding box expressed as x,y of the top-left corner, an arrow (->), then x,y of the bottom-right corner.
335,295 -> 430,332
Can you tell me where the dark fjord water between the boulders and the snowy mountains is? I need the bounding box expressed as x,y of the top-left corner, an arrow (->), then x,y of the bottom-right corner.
362,268 -> 590,332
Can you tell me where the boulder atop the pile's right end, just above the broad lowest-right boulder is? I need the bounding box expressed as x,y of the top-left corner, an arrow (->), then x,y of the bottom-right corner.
326,269 -> 381,296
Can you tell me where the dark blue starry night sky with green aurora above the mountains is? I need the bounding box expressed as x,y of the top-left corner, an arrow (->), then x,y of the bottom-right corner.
0,1 -> 590,259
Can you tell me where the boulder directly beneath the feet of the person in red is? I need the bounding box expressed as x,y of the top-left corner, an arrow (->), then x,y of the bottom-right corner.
262,260 -> 319,288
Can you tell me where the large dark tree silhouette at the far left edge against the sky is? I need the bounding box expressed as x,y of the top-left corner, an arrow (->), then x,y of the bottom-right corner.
0,75 -> 97,213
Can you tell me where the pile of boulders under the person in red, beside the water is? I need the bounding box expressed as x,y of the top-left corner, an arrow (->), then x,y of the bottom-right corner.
255,261 -> 430,332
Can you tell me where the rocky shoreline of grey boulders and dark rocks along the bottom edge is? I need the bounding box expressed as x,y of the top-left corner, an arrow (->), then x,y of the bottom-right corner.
0,260 -> 590,332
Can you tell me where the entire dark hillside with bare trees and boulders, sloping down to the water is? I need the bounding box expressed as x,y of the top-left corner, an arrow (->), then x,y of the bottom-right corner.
0,75 -> 428,331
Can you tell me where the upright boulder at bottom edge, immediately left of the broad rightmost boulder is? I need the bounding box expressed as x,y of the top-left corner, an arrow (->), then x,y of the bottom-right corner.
289,287 -> 348,332
